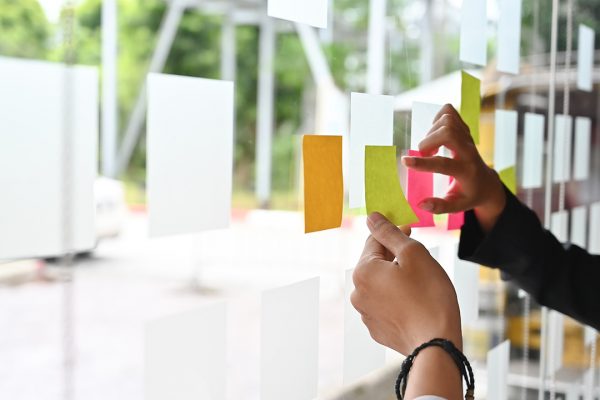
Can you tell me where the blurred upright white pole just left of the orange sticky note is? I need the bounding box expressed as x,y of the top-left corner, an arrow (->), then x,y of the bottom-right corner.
256,16 -> 276,207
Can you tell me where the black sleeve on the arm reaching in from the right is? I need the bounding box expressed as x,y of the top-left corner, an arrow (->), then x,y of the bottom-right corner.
458,189 -> 600,329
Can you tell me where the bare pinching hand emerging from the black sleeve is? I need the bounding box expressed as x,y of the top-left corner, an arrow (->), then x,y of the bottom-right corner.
402,104 -> 506,231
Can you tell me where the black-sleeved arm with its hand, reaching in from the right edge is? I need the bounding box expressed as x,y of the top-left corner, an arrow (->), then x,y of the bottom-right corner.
403,105 -> 600,329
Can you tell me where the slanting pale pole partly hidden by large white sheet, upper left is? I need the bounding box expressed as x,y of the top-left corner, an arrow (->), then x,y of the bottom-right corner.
115,1 -> 185,175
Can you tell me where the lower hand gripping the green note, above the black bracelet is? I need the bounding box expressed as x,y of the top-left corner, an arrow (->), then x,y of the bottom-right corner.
351,213 -> 462,355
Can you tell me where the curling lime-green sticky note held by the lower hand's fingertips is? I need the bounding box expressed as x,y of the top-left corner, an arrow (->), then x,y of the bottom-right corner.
365,146 -> 419,225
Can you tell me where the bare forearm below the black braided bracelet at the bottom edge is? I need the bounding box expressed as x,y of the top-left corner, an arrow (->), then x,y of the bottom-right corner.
404,347 -> 464,400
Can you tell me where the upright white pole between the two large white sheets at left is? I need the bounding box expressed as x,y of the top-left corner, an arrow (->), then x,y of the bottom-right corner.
102,0 -> 118,177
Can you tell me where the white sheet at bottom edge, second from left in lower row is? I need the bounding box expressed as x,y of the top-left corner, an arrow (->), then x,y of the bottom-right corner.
260,278 -> 319,400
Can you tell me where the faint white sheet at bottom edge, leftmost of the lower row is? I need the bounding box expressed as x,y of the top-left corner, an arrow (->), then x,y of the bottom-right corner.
144,303 -> 227,400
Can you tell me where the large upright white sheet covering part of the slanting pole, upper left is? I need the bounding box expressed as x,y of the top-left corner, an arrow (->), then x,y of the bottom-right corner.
147,74 -> 234,236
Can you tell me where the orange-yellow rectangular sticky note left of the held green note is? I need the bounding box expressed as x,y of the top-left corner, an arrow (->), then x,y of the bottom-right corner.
302,135 -> 344,233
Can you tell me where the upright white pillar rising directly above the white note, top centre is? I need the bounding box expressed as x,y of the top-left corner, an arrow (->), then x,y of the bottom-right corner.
367,0 -> 387,94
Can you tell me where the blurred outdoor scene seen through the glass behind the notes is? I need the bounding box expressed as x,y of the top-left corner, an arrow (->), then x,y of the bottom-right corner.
0,0 -> 600,399
